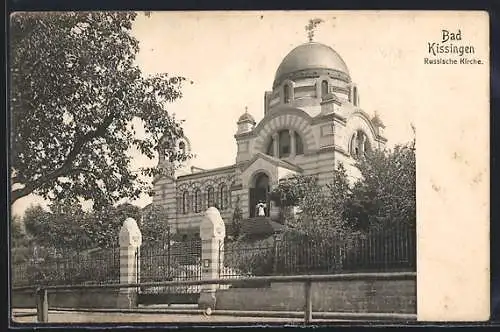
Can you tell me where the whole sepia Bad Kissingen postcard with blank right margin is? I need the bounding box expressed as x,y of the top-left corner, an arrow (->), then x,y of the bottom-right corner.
9,11 -> 490,325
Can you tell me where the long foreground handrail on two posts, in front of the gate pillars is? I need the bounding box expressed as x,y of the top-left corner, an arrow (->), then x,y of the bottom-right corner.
12,272 -> 416,324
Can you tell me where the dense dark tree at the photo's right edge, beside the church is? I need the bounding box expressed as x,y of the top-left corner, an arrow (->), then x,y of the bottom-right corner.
347,141 -> 416,229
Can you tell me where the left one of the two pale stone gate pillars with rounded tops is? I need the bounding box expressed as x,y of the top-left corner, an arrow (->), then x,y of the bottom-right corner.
117,218 -> 142,309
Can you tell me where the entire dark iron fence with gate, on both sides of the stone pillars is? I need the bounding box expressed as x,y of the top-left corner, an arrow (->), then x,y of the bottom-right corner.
11,225 -> 416,293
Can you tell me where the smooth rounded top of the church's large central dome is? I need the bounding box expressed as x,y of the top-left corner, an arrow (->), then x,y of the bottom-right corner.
275,42 -> 349,85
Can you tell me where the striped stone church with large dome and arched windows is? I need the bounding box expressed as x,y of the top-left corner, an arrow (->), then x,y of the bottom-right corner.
153,42 -> 386,234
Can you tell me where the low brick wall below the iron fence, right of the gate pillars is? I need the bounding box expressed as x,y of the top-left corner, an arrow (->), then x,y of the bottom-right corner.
216,279 -> 417,314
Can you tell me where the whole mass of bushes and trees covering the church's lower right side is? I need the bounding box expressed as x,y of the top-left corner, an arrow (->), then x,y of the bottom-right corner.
271,141 -> 416,237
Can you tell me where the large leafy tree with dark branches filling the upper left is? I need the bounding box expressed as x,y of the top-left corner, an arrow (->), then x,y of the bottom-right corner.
10,12 -> 190,210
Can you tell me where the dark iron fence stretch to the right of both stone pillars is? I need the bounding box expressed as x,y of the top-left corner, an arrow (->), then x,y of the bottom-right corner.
219,225 -> 416,278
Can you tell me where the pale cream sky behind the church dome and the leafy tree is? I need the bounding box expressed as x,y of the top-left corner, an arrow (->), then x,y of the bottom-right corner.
13,12 -> 415,214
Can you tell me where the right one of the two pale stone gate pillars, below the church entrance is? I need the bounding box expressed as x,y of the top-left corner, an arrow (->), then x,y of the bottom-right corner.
198,207 -> 226,310
